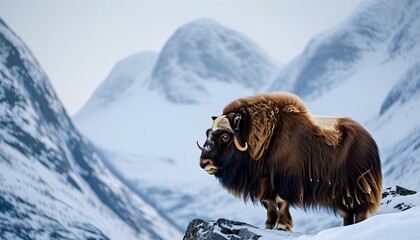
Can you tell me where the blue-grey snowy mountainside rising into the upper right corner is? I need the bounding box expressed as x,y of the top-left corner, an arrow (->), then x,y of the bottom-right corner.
269,0 -> 420,100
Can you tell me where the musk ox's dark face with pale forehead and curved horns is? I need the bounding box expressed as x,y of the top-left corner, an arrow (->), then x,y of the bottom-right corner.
197,113 -> 248,176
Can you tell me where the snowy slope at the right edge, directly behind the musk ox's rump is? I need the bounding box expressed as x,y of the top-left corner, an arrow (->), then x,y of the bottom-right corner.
369,60 -> 420,189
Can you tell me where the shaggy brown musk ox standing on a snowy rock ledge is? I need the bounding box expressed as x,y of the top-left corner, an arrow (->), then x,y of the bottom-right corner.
197,93 -> 382,231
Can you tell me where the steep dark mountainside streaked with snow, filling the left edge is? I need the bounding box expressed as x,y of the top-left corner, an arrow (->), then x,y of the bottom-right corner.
0,17 -> 180,239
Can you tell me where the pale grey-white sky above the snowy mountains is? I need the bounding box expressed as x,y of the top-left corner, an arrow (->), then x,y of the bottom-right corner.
0,0 -> 364,115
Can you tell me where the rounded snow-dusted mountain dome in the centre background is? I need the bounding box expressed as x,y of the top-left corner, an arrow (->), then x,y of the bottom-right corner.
151,19 -> 277,103
